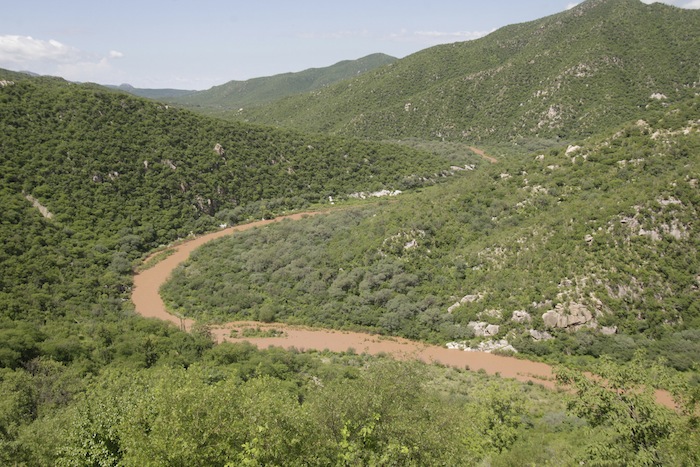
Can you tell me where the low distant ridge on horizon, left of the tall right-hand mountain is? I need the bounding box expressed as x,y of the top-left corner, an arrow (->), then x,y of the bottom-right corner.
161,53 -> 397,113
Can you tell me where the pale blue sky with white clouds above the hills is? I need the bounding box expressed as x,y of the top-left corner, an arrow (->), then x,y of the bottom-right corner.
0,0 -> 700,90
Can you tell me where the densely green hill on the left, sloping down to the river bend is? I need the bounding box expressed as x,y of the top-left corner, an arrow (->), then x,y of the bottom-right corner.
0,71 -> 446,368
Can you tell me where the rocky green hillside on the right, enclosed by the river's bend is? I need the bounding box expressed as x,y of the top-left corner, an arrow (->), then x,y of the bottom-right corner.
162,98 -> 700,370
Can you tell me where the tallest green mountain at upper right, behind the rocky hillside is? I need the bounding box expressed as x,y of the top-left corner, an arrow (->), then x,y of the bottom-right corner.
228,0 -> 700,141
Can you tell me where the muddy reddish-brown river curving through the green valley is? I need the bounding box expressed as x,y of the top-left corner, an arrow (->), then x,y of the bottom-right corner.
131,212 -> 673,407
